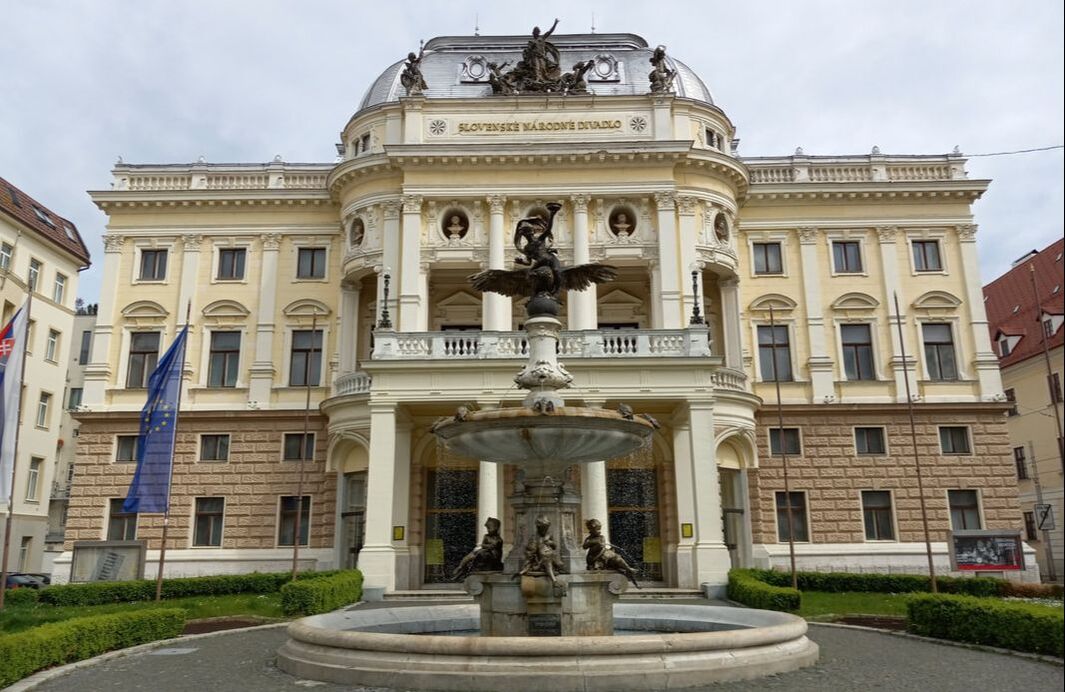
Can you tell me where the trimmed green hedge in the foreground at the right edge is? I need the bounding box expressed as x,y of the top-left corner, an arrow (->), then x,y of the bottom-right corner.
906,594 -> 1065,656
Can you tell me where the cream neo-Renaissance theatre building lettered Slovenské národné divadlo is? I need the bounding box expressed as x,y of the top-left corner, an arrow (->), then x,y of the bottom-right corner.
60,29 -> 1019,591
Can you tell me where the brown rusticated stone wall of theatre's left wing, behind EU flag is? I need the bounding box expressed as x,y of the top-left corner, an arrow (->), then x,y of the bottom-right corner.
66,411 -> 337,550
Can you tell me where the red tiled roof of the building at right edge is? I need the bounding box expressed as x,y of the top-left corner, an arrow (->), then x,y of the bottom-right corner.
984,238 -> 1065,367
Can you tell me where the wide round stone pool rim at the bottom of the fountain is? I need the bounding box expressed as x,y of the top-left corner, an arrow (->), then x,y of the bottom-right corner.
277,604 -> 818,692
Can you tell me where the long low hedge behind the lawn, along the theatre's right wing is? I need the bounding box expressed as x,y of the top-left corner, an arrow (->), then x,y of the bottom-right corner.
748,570 -> 1009,596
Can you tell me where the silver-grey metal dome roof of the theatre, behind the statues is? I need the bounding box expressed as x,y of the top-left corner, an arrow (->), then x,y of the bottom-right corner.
359,34 -> 714,111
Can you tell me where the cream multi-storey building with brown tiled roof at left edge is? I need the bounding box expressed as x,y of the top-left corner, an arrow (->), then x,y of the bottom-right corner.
0,173 -> 88,572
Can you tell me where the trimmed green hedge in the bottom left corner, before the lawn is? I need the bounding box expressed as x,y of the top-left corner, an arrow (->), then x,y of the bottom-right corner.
0,608 -> 185,687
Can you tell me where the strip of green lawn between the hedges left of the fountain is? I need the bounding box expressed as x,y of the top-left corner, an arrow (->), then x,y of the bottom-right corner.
0,593 -> 285,635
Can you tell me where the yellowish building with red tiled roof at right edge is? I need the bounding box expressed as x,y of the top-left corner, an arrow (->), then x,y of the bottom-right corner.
984,241 -> 1065,581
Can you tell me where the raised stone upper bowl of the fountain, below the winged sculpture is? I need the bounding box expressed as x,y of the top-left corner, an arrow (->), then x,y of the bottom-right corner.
433,407 -> 654,464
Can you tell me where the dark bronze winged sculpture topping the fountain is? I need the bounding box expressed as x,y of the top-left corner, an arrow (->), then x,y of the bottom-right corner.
470,202 -> 618,315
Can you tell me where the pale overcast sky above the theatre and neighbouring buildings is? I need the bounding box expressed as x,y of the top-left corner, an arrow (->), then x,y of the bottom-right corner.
0,0 -> 1065,301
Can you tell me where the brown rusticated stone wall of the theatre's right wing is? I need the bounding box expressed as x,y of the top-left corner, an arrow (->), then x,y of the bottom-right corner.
749,405 -> 1021,543
